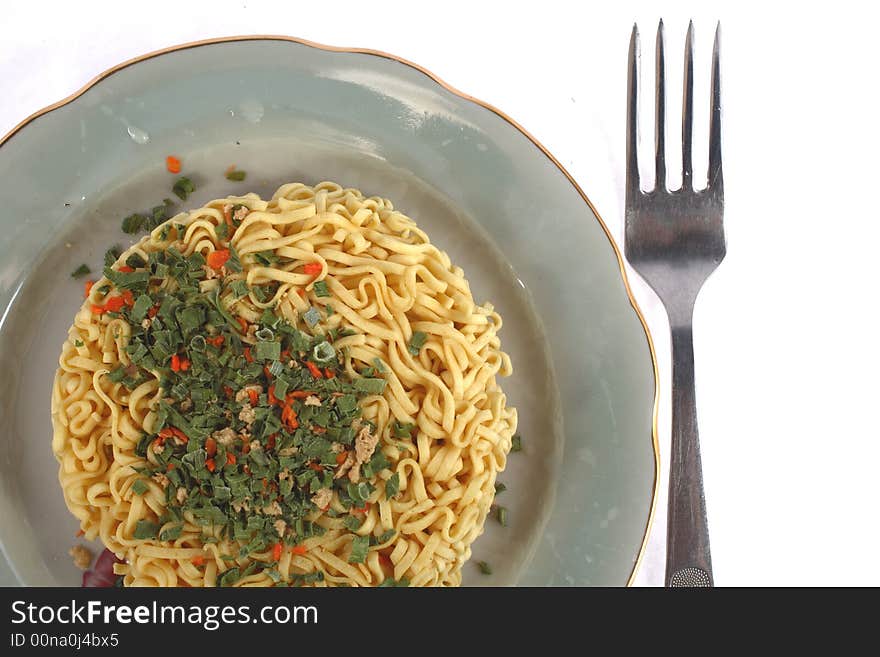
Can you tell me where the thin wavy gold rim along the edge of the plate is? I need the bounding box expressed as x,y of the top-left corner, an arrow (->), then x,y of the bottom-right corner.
0,34 -> 660,586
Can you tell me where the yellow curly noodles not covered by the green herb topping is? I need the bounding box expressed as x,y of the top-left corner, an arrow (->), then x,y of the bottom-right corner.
52,182 -> 517,586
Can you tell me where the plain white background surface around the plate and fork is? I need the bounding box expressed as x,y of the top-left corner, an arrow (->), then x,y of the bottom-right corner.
0,0 -> 880,586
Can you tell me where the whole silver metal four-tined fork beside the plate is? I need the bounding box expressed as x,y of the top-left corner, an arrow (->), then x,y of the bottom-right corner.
624,20 -> 727,587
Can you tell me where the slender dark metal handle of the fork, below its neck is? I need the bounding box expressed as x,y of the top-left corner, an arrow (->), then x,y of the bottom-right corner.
666,322 -> 713,586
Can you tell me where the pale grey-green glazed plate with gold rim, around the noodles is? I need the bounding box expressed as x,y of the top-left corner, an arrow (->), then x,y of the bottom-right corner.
0,36 -> 658,586
